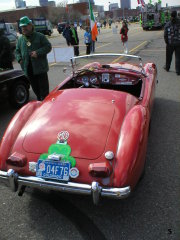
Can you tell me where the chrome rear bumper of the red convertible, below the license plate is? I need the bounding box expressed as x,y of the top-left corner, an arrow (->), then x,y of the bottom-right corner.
0,169 -> 131,204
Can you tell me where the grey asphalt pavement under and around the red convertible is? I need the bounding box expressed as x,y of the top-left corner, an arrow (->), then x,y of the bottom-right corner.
0,24 -> 180,240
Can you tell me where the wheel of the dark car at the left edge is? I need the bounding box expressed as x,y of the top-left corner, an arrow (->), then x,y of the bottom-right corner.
9,81 -> 29,108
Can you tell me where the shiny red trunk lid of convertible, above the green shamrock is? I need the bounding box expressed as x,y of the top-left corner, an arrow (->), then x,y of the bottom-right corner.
23,101 -> 114,159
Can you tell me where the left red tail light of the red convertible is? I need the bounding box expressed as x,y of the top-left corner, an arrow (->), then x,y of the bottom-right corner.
6,152 -> 27,167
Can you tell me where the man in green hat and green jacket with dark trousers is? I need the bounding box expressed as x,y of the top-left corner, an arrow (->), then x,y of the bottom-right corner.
15,16 -> 52,101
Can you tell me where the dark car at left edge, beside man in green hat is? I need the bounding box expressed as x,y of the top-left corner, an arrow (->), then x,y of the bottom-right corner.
0,69 -> 30,108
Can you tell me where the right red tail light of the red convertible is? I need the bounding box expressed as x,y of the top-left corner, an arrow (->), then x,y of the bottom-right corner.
88,162 -> 112,177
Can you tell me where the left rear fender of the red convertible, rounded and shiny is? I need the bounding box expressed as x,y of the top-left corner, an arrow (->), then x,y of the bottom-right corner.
0,101 -> 41,170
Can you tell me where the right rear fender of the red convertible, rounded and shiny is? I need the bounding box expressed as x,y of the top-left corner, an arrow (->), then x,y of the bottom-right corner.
114,105 -> 149,188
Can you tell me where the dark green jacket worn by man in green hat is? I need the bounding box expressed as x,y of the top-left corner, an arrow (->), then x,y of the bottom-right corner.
15,32 -> 52,76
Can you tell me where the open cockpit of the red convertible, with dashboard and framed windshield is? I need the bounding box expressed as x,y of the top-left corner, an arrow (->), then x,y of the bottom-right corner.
59,54 -> 145,99
